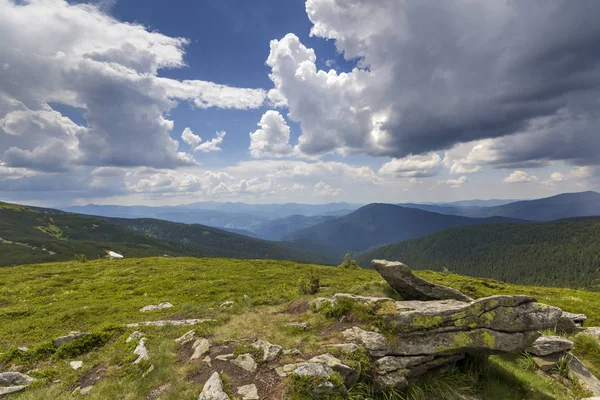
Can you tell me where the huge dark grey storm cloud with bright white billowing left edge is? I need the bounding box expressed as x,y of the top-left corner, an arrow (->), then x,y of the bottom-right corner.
267,0 -> 600,166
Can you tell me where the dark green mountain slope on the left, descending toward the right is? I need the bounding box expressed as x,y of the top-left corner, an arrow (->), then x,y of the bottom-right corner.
0,203 -> 335,266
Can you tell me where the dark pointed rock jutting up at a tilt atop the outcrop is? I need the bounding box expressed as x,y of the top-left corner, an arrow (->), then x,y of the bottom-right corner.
371,260 -> 472,302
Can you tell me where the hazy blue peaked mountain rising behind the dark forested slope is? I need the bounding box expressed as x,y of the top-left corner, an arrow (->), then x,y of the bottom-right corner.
286,204 -> 523,252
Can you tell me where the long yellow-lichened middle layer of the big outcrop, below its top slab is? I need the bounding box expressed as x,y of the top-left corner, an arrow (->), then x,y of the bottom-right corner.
342,327 -> 539,356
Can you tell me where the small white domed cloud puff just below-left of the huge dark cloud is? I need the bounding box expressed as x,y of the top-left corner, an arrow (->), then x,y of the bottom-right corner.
250,110 -> 293,158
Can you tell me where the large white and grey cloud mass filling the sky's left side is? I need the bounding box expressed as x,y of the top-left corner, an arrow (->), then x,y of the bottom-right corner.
0,0 -> 266,171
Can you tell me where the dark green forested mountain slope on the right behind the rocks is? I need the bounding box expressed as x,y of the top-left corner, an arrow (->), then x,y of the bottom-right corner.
357,218 -> 600,288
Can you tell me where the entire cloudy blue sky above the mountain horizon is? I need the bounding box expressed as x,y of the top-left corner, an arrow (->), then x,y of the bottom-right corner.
0,0 -> 600,206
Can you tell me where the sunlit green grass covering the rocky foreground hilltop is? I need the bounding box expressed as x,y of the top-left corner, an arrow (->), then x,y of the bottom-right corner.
0,257 -> 600,400
